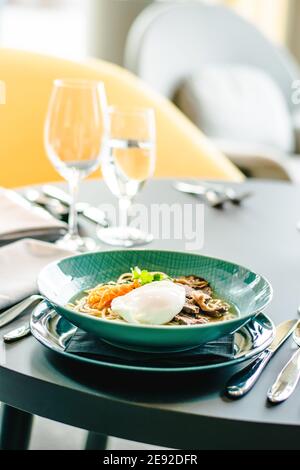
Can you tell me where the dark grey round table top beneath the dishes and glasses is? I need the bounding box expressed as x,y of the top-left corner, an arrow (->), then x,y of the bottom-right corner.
0,180 -> 300,449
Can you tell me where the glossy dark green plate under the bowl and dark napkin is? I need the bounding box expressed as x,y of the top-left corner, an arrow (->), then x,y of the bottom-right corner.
30,302 -> 275,373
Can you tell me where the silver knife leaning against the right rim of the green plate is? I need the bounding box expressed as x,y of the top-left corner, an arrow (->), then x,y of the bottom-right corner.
225,320 -> 298,399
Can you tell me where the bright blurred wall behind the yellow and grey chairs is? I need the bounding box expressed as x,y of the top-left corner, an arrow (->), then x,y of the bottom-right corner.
0,0 -> 300,64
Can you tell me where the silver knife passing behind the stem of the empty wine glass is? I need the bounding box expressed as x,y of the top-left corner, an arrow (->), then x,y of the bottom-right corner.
42,184 -> 109,228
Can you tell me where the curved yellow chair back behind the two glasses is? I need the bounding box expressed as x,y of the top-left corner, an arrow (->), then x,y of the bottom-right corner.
0,49 -> 243,187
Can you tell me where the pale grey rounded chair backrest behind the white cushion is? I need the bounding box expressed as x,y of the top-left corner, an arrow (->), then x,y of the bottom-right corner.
125,1 -> 297,108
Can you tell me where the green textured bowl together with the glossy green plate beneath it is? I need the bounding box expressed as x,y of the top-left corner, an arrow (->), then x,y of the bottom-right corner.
31,250 -> 274,372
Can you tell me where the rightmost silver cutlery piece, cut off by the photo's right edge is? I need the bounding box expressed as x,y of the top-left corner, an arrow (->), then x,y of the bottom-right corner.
267,322 -> 300,404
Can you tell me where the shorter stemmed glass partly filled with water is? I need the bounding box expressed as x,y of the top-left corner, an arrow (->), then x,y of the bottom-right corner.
97,107 -> 156,247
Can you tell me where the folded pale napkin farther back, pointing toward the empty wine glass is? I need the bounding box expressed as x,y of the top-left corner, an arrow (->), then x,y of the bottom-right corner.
0,188 -> 66,245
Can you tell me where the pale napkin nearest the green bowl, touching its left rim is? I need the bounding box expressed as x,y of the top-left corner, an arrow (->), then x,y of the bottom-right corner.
0,239 -> 74,310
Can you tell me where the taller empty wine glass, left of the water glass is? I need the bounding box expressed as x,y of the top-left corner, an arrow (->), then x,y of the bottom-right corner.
44,79 -> 108,252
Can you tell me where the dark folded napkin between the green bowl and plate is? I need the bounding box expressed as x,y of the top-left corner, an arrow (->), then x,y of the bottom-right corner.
66,329 -> 234,367
